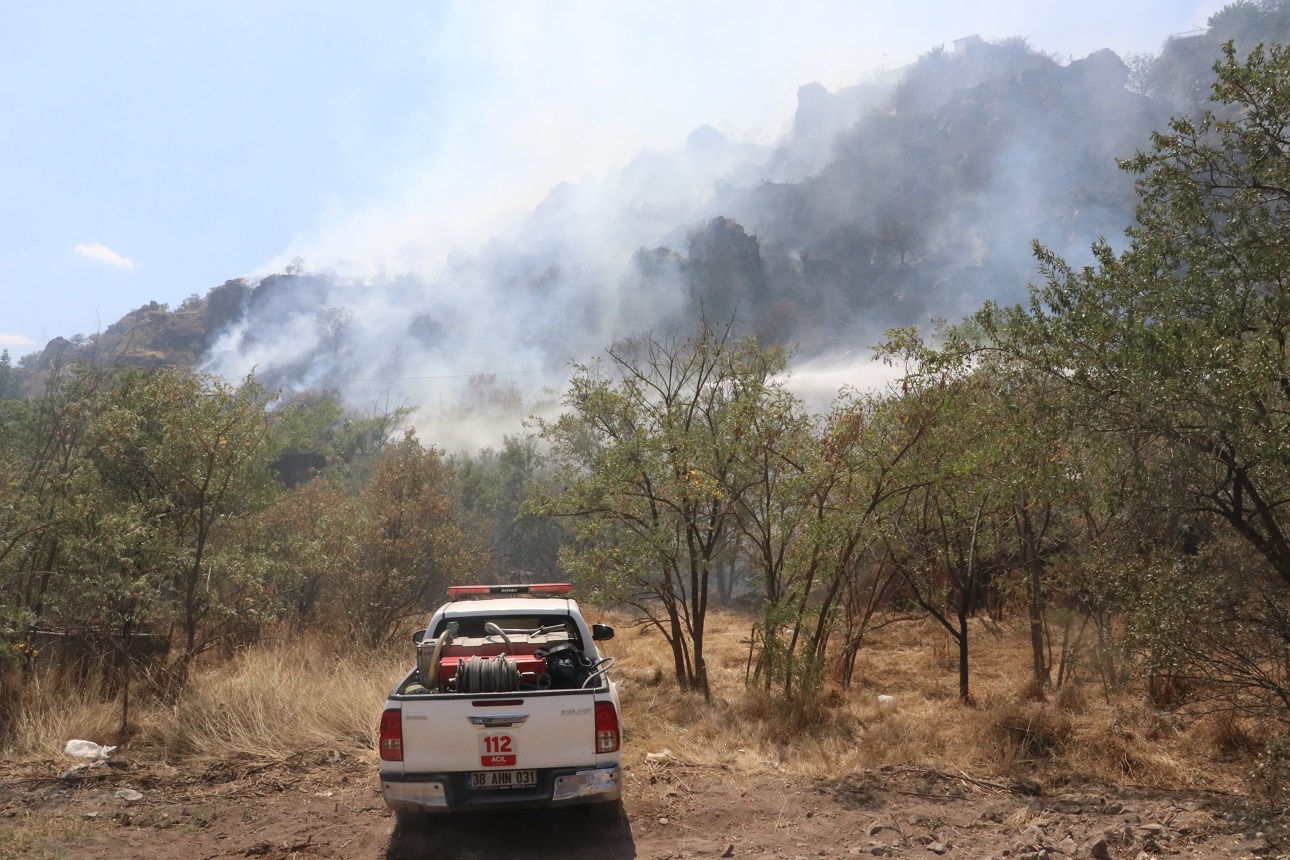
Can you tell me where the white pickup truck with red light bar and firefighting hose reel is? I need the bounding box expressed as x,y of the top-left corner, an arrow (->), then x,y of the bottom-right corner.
381,583 -> 622,821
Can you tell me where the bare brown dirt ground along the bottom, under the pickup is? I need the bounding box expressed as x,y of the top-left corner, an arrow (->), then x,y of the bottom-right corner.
0,756 -> 1290,860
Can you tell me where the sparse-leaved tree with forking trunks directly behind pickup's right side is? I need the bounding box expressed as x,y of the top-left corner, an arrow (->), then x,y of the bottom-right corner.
537,326 -> 784,695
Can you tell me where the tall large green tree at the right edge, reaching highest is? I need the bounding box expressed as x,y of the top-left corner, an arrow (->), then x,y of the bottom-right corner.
977,43 -> 1290,699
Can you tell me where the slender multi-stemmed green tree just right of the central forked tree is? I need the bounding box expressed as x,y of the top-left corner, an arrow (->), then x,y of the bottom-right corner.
740,391 -> 937,698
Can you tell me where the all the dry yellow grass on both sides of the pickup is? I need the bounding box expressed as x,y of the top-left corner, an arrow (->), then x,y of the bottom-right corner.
0,611 -> 1260,790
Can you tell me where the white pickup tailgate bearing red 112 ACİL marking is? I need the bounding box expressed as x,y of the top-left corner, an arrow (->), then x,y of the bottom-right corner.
401,690 -> 596,774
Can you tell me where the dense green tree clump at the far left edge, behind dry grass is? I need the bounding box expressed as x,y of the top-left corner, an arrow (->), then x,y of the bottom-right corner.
0,362 -> 279,731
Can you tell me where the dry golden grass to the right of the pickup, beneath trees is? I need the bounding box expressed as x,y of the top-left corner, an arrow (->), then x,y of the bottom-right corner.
606,612 -> 1253,792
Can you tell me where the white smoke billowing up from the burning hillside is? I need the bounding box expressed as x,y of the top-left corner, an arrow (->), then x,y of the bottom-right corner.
198,5 -> 1217,447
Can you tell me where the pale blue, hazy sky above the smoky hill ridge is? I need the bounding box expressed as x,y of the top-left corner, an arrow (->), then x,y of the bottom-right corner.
0,0 -> 1224,356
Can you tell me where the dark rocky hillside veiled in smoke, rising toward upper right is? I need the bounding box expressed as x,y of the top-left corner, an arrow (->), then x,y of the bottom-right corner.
19,0 -> 1290,396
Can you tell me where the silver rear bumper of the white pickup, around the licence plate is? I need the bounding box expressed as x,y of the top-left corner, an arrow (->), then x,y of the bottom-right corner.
381,765 -> 623,812
